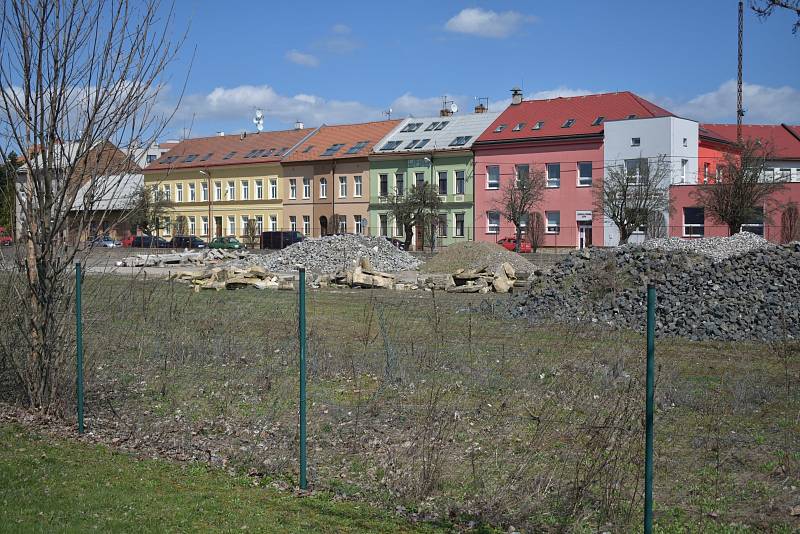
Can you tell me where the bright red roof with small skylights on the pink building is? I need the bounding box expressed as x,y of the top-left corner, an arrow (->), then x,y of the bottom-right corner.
476,91 -> 674,144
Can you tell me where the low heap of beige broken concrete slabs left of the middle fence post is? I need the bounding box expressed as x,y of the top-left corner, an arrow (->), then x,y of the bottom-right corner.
174,265 -> 294,292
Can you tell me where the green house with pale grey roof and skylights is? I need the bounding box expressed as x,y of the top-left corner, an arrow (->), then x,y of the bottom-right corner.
369,108 -> 499,249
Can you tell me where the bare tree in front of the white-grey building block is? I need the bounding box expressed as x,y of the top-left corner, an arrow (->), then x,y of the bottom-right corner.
592,156 -> 670,244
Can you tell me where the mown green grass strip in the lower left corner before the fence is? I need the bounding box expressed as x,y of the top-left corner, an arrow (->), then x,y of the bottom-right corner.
0,425 -> 438,532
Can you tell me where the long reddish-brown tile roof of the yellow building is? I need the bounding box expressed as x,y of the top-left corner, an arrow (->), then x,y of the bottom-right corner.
145,128 -> 315,171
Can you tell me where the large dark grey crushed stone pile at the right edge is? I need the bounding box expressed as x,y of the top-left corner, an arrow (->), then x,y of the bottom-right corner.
512,236 -> 800,340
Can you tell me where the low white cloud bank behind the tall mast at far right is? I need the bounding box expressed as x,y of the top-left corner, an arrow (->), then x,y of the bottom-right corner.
656,80 -> 800,124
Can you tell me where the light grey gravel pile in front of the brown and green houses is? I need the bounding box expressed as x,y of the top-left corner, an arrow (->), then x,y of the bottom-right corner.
247,234 -> 421,274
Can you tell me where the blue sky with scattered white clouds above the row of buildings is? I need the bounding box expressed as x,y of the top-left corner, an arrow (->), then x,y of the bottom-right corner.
159,0 -> 800,137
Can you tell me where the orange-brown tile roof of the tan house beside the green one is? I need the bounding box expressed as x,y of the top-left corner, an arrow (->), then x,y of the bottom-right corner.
283,120 -> 402,163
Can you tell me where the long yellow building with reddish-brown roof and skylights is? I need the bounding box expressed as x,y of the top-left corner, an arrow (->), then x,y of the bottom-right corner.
143,128 -> 315,246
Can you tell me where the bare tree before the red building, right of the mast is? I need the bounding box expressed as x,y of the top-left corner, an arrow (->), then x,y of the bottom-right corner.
693,139 -> 785,235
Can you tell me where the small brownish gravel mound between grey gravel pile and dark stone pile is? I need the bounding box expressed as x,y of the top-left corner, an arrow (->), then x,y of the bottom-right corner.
421,241 -> 536,274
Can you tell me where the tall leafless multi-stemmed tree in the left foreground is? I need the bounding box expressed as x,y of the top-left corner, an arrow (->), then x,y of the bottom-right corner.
0,0 -> 183,413
